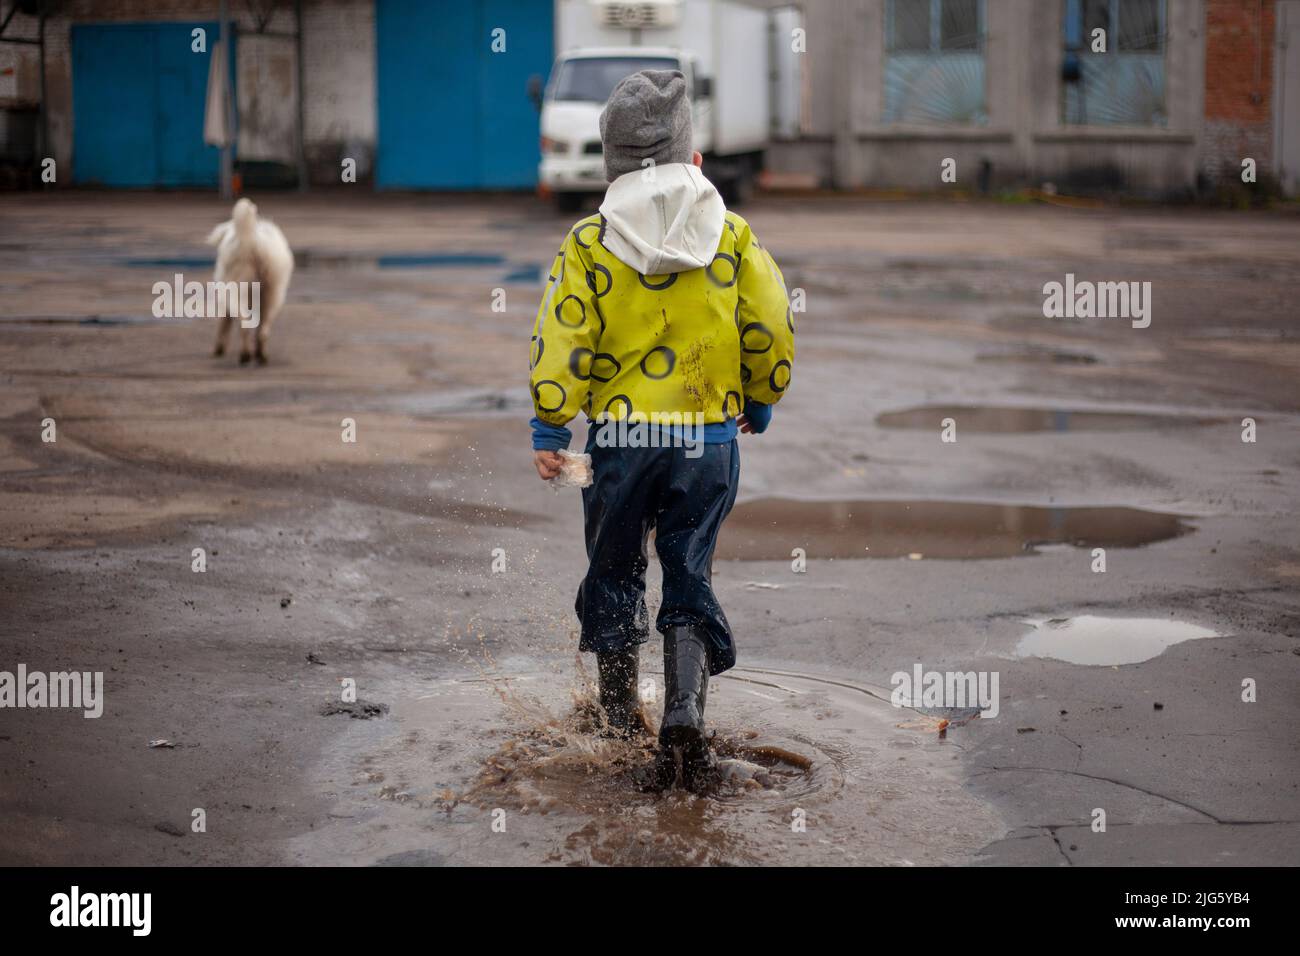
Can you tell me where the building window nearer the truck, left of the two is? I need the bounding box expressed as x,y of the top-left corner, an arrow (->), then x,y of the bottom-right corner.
884,0 -> 988,125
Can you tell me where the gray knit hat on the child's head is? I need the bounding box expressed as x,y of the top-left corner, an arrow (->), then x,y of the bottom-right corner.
601,70 -> 694,182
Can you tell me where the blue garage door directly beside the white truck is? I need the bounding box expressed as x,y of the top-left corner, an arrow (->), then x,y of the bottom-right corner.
374,0 -> 554,189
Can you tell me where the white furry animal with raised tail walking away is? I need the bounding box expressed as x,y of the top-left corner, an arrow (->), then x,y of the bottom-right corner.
208,199 -> 294,365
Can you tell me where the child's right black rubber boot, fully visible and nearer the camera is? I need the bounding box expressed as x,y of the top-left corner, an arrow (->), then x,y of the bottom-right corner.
657,627 -> 714,790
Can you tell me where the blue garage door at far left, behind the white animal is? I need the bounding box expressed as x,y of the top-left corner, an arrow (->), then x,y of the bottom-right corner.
72,23 -> 233,186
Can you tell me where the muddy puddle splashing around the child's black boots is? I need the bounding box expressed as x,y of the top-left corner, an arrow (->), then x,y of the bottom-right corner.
295,650 -> 1002,865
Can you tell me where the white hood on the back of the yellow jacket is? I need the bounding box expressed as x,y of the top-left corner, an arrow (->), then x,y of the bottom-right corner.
601,163 -> 727,276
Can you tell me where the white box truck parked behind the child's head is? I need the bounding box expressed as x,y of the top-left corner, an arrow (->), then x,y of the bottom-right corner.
530,0 -> 797,212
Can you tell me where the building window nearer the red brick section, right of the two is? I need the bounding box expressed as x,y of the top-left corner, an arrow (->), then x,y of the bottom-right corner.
1061,0 -> 1166,126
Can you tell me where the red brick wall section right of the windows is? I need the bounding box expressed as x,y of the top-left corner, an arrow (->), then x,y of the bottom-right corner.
1200,0 -> 1275,179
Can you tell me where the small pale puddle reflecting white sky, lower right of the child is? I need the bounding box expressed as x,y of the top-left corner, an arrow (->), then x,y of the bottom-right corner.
1015,614 -> 1222,666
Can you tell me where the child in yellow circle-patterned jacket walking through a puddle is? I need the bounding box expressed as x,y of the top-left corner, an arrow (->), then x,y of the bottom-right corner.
530,70 -> 794,787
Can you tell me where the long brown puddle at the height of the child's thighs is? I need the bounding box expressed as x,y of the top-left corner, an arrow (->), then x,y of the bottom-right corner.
716,498 -> 1191,561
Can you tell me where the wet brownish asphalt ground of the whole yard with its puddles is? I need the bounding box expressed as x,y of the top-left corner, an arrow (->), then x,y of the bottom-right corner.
0,194 -> 1300,865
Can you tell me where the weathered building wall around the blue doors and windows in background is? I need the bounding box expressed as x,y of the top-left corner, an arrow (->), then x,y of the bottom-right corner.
0,0 -> 1275,196
